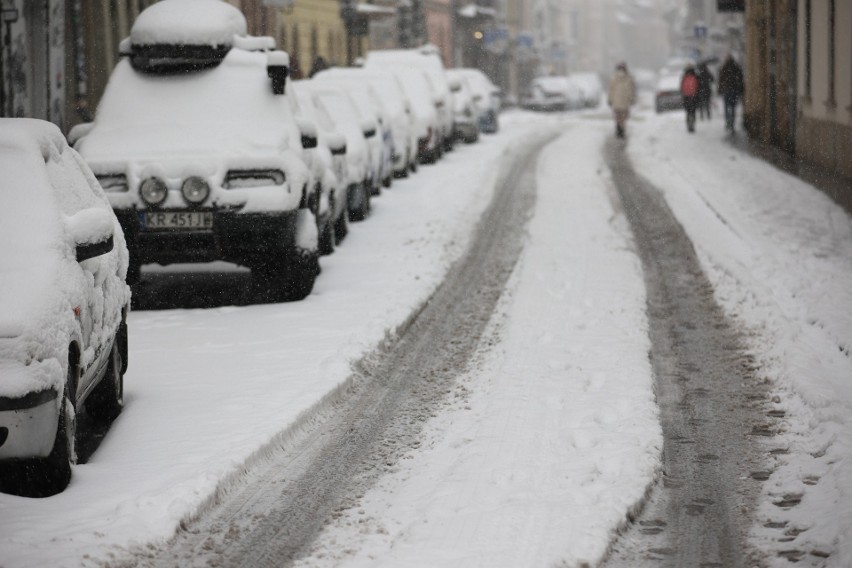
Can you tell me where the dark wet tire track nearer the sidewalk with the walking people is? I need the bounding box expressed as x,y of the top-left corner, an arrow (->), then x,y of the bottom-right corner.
604,140 -> 767,568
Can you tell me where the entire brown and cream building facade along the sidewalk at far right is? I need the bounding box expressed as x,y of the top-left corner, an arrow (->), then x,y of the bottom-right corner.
744,0 -> 852,182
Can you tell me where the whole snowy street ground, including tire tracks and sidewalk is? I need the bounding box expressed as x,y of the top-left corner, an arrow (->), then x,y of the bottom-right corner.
0,105 -> 852,568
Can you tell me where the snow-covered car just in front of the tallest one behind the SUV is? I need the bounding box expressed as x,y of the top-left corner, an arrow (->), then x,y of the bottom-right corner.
314,67 -> 417,181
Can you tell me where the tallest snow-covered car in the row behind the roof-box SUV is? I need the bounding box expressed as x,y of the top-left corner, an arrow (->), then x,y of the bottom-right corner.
364,45 -> 453,150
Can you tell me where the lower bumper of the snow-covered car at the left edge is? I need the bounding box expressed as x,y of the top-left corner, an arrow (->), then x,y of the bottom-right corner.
0,390 -> 59,460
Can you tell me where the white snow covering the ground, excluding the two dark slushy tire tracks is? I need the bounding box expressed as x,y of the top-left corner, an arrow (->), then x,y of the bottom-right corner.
0,108 -> 852,568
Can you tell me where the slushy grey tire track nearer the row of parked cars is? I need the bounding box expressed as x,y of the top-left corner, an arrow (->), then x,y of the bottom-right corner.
120,132 -> 555,568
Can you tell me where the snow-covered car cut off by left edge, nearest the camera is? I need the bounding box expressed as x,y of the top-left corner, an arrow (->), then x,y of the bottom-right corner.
0,118 -> 130,496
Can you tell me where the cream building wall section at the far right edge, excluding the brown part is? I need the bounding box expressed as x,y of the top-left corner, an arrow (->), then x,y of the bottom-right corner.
796,0 -> 852,178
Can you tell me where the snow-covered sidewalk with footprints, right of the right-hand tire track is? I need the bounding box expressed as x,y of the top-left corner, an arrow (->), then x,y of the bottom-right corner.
628,113 -> 852,567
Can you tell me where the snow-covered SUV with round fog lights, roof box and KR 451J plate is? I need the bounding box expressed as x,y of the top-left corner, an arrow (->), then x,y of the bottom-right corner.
70,0 -> 319,300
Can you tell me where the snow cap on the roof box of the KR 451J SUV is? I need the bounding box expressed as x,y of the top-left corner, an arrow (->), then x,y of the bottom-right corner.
130,0 -> 247,46
